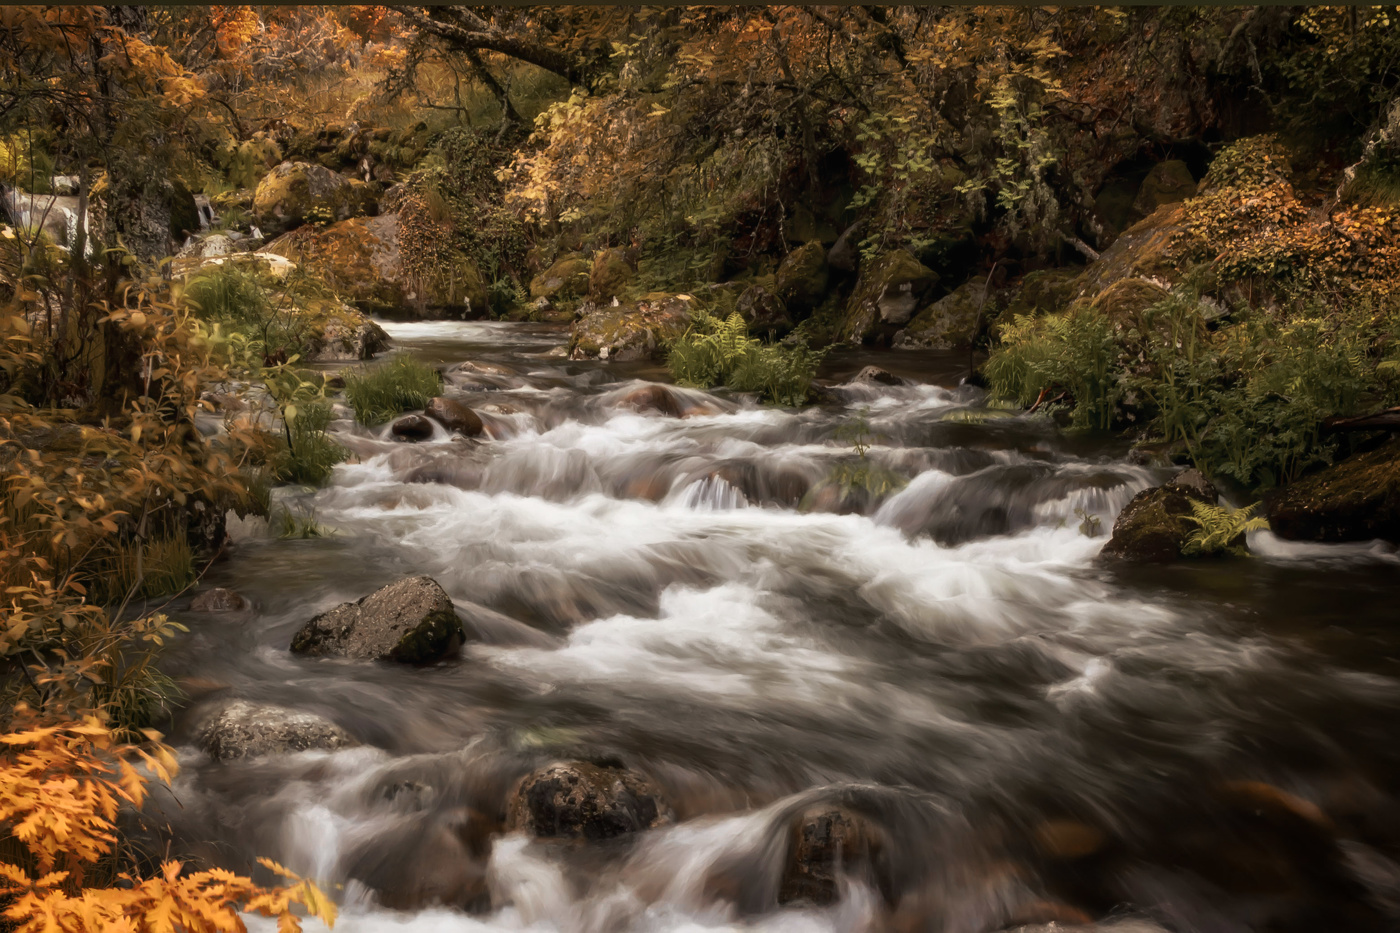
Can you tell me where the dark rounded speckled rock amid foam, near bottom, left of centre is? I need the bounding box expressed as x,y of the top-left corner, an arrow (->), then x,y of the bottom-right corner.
505,761 -> 672,841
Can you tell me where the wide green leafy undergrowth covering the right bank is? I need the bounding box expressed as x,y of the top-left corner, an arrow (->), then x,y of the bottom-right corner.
984,293 -> 1400,489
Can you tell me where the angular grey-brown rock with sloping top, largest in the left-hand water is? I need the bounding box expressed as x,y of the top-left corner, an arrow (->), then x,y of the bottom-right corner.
291,576 -> 462,664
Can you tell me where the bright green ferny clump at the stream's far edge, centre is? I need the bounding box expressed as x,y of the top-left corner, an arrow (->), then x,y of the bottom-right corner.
666,311 -> 826,405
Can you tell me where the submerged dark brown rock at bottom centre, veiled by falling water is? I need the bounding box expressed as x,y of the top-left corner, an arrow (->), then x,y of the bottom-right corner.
778,807 -> 882,905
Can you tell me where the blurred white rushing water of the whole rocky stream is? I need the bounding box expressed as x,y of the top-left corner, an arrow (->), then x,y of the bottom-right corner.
150,324 -> 1400,933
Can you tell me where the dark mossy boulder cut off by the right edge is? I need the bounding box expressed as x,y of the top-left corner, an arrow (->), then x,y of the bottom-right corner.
1264,438 -> 1400,544
